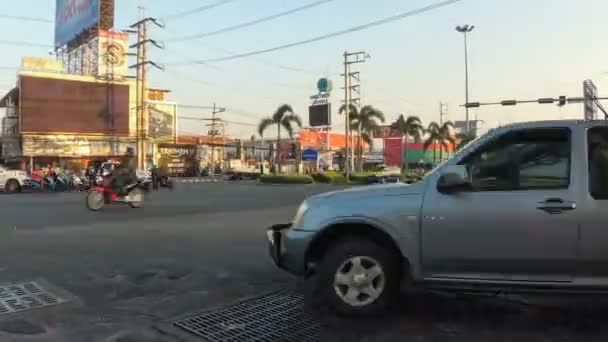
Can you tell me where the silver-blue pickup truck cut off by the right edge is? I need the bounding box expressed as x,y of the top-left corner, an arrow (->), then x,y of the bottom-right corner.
267,120 -> 608,314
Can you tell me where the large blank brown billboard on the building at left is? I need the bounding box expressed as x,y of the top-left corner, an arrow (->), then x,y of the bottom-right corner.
19,76 -> 129,135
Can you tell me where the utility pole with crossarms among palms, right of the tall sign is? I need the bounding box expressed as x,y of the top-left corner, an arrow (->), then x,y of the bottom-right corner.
344,51 -> 369,181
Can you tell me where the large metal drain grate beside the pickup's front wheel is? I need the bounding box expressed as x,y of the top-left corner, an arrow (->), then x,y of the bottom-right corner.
174,292 -> 321,342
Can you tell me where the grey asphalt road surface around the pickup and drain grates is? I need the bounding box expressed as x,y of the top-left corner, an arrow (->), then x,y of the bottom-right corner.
0,182 -> 608,342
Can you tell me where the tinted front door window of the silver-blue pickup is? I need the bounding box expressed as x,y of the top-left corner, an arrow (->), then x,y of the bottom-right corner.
461,128 -> 571,191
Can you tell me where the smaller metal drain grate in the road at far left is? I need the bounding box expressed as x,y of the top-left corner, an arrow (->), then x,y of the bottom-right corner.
0,281 -> 67,315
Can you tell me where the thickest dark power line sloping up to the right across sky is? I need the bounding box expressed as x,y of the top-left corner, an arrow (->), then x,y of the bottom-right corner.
170,0 -> 461,64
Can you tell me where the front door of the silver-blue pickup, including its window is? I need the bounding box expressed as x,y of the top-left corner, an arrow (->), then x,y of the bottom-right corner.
422,127 -> 579,282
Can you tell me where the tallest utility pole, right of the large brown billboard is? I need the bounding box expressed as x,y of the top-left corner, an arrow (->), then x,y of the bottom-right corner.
127,7 -> 164,169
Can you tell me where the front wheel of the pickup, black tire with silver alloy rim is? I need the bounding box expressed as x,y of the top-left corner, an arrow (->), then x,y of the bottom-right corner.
315,237 -> 401,316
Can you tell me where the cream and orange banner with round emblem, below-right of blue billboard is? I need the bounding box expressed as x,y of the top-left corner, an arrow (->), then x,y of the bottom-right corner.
97,30 -> 129,77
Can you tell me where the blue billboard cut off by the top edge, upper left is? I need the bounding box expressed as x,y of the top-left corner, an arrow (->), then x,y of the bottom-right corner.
55,0 -> 100,47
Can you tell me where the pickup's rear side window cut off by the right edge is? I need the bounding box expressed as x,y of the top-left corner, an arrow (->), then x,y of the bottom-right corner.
587,127 -> 608,200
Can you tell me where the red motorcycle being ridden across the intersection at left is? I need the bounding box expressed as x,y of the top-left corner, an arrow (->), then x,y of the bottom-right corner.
87,177 -> 144,211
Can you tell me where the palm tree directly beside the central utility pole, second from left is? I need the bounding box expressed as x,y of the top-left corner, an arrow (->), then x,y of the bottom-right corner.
340,105 -> 384,171
